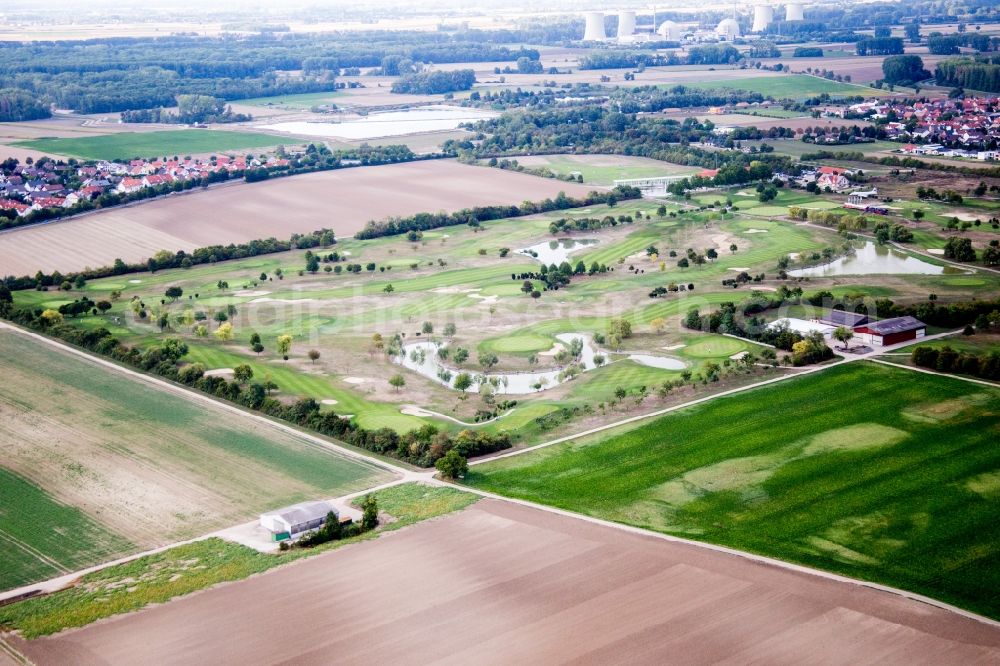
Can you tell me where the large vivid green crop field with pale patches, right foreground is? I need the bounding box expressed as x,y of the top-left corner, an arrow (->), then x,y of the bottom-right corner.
467,364 -> 1000,617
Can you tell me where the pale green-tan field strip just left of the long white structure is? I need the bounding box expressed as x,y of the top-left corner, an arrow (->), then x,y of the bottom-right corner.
500,155 -> 701,187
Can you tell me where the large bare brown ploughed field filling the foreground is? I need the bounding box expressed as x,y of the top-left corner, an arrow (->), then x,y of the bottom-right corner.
8,500 -> 1000,665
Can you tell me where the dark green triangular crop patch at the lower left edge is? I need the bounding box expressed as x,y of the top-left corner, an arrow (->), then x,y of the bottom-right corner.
0,467 -> 132,590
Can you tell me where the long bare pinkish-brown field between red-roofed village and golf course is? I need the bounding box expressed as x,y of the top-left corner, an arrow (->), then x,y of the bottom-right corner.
0,160 -> 593,275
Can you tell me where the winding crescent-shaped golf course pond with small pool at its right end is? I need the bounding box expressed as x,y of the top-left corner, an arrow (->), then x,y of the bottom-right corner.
393,333 -> 687,395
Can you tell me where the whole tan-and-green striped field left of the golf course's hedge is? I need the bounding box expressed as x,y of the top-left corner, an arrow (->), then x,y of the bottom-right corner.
0,328 -> 390,589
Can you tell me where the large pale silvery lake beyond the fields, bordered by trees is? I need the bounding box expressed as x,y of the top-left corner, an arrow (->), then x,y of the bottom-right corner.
262,106 -> 497,139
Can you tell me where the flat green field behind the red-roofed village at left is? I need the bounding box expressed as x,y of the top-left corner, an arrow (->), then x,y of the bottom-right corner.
14,129 -> 288,160
